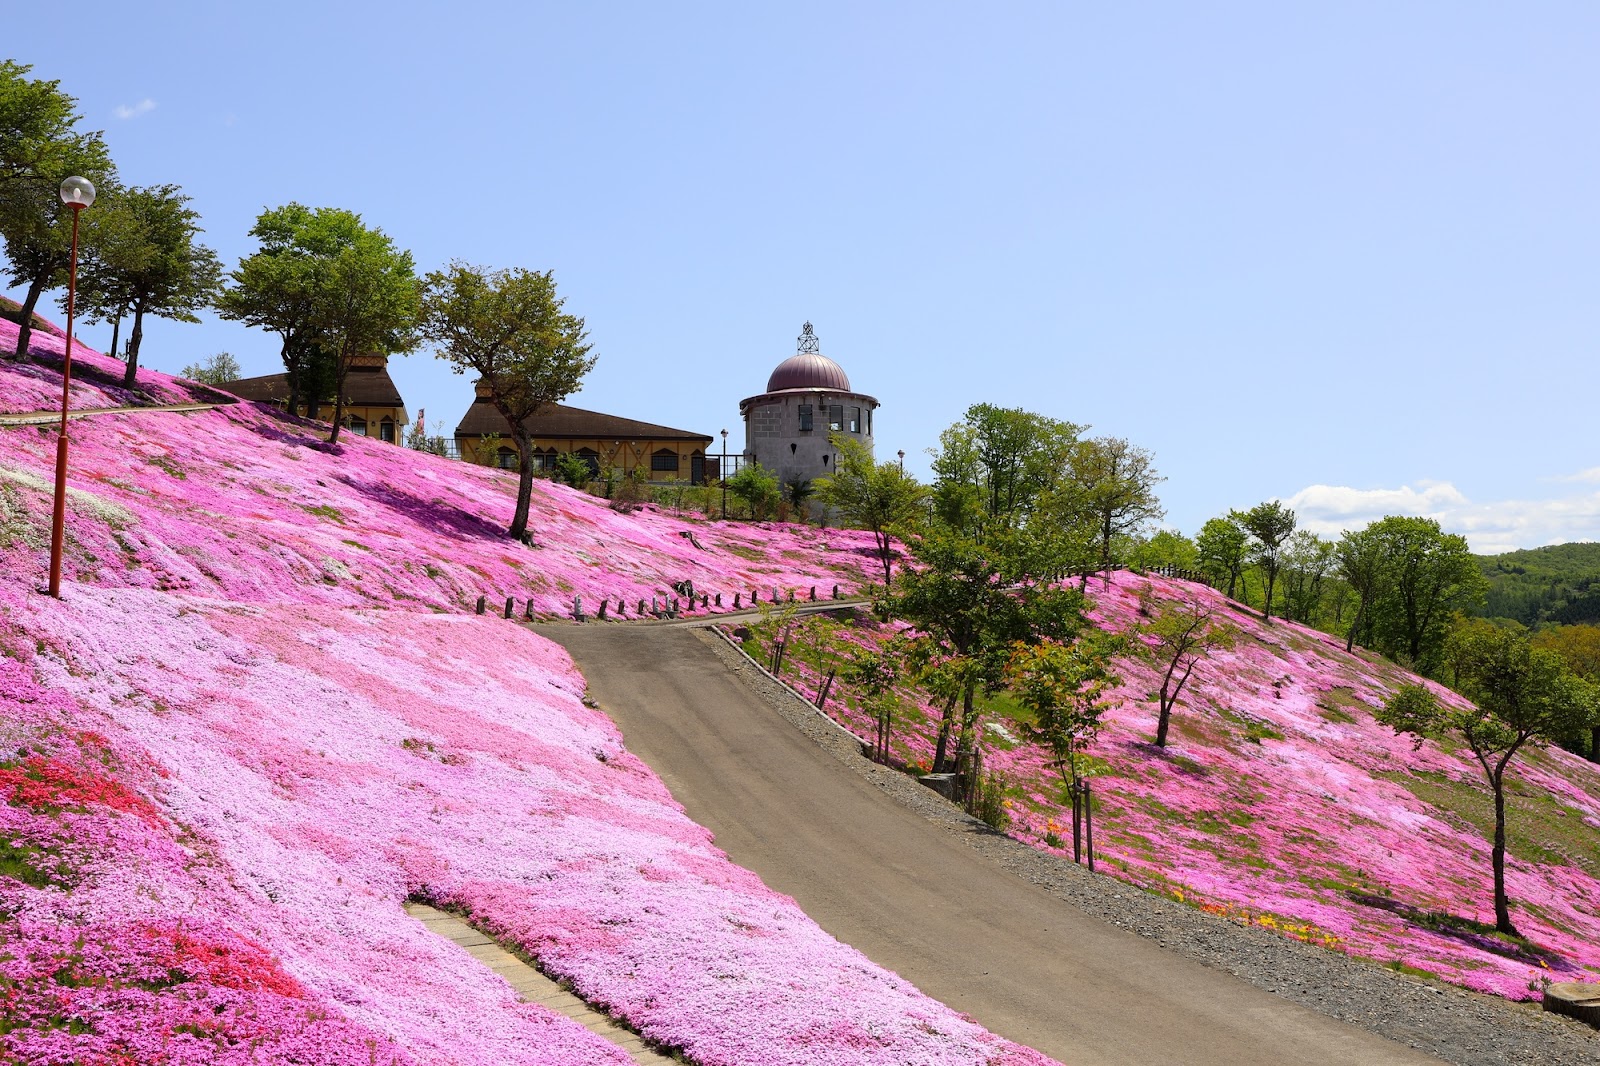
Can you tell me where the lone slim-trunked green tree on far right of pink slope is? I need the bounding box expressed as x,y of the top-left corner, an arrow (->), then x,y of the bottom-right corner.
1378,623 -> 1597,935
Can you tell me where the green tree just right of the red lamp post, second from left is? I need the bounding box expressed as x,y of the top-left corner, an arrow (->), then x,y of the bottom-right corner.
78,186 -> 222,389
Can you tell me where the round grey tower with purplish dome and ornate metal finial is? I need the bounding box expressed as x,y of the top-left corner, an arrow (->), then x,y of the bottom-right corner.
739,322 -> 878,491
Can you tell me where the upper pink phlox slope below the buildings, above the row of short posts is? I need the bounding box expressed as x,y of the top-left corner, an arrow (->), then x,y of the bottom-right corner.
0,320 -> 875,616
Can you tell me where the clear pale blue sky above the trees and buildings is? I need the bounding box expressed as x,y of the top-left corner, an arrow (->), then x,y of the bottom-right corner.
0,0 -> 1600,551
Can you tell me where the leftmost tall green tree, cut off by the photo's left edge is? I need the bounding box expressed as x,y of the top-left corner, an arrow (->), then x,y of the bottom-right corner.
0,59 -> 117,359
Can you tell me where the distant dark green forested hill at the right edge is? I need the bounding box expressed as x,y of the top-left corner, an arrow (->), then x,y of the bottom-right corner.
1477,544 -> 1600,626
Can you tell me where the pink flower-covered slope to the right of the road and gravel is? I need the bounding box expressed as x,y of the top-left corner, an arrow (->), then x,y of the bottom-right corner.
732,573 -> 1600,999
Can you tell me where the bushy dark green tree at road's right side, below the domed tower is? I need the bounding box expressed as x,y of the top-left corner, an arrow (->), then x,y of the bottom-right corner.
883,523 -> 1083,773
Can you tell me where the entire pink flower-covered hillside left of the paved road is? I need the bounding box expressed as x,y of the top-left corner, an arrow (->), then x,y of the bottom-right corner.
0,323 -> 1048,1066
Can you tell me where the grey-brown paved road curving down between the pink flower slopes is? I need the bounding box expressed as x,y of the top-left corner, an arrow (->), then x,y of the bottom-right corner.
538,624 -> 1437,1066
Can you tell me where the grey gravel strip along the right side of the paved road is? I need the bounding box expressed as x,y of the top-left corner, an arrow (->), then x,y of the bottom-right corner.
698,632 -> 1600,1066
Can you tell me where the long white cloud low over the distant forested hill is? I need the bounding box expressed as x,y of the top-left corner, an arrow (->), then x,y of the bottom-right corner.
1283,475 -> 1600,554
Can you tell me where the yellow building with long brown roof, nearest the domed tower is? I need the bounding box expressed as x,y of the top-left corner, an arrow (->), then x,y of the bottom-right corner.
456,384 -> 718,485
